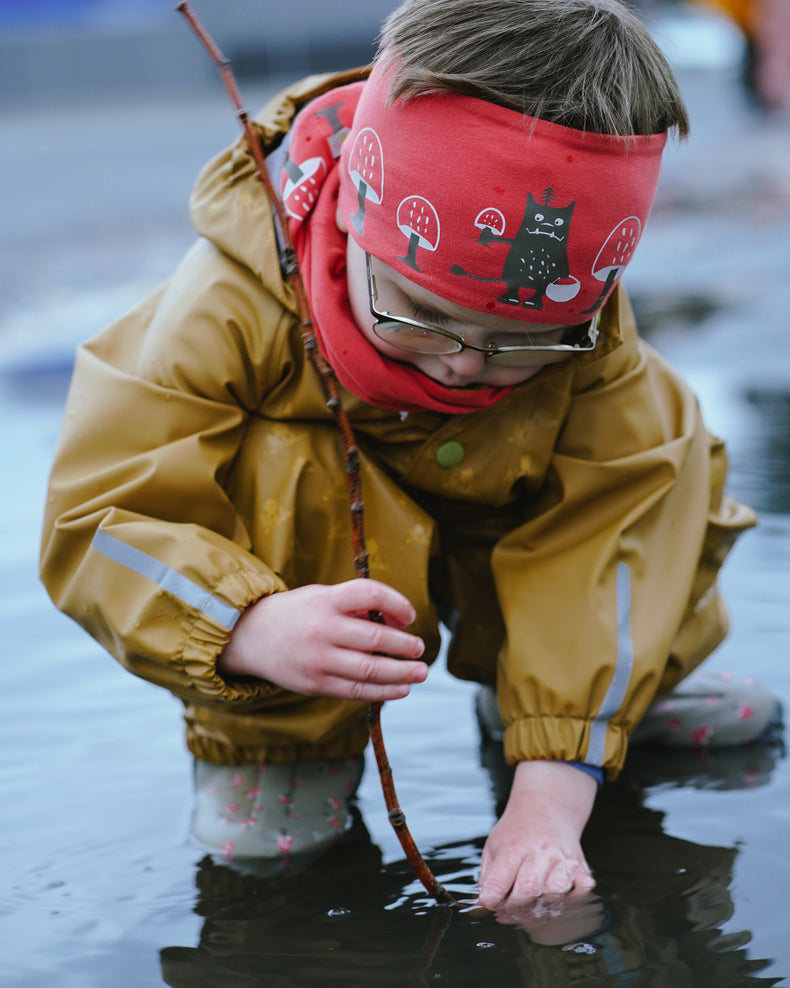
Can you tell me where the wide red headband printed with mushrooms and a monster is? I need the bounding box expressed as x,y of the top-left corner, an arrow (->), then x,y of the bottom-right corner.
340,67 -> 666,324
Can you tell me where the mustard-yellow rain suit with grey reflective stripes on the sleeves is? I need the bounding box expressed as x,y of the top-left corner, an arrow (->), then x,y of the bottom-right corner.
41,73 -> 754,775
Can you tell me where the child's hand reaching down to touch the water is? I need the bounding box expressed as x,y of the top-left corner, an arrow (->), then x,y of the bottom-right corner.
478,761 -> 597,912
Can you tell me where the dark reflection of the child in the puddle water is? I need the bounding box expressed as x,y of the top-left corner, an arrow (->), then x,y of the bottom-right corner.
160,745 -> 781,988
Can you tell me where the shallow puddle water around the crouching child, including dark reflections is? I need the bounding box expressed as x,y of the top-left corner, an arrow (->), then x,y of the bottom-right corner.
0,13 -> 790,988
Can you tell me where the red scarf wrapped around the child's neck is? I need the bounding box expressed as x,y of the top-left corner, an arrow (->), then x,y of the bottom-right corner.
281,83 -> 512,414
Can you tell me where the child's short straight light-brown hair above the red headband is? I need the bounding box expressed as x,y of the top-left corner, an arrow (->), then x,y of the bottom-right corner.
377,0 -> 689,137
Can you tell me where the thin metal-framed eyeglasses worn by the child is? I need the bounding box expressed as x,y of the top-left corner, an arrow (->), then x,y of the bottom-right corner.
365,252 -> 600,367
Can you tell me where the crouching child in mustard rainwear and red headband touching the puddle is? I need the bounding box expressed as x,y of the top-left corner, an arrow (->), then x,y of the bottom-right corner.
42,0 -> 762,908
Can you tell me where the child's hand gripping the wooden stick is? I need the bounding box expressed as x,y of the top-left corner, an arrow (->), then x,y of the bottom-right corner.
217,579 -> 428,701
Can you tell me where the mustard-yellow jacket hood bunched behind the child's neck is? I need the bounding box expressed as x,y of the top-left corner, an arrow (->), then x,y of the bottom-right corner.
190,69 -> 368,311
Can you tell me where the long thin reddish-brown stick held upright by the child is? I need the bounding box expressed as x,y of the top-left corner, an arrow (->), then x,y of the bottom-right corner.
176,2 -> 456,905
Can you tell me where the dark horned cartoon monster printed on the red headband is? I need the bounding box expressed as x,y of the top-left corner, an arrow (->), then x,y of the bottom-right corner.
450,188 -> 576,309
